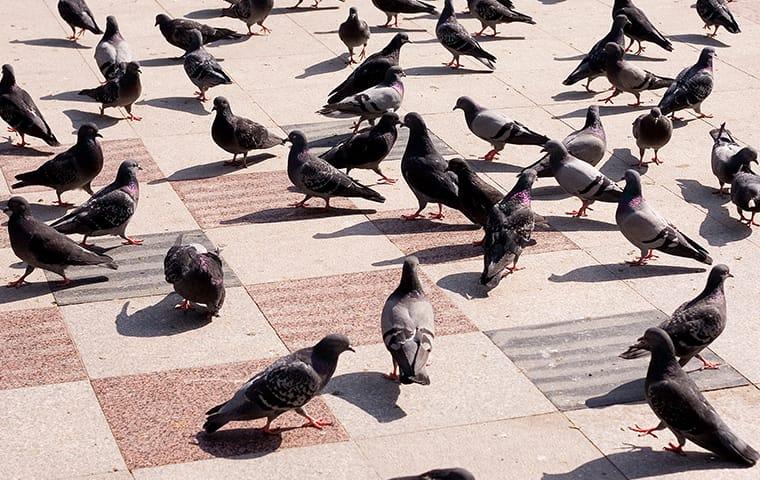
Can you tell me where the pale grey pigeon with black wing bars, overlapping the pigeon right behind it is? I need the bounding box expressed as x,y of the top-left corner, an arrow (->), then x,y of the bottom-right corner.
544,140 -> 623,217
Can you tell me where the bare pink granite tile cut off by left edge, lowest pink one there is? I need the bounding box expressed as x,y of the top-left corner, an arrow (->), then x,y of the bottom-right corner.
0,308 -> 87,390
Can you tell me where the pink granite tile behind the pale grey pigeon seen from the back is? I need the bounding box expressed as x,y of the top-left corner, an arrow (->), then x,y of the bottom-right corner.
247,268 -> 476,350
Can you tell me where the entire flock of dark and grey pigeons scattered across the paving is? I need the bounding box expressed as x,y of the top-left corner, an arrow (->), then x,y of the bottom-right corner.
0,0 -> 760,479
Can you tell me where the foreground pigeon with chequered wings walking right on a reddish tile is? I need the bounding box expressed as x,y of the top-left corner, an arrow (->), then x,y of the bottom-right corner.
203,334 -> 354,434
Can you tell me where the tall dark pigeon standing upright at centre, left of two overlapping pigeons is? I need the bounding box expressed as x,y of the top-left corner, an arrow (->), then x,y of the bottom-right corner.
401,112 -> 460,220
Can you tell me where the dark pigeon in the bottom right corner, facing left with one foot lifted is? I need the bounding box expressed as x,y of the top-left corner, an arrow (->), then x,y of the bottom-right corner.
631,327 -> 760,466
